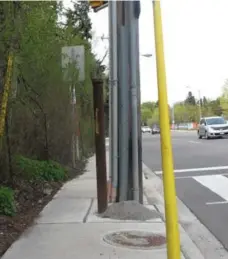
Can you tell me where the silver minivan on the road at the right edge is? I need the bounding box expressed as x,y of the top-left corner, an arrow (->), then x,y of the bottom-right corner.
197,116 -> 228,139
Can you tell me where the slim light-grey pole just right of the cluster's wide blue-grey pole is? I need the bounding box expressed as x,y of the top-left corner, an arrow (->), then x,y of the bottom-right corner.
128,1 -> 139,201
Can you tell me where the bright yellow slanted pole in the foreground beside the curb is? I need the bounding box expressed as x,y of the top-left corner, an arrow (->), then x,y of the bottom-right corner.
153,0 -> 181,259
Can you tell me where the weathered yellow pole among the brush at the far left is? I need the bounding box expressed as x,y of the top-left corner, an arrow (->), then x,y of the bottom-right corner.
0,54 -> 13,137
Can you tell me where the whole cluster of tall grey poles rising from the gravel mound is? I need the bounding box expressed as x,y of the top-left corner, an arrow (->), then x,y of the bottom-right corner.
90,1 -> 143,202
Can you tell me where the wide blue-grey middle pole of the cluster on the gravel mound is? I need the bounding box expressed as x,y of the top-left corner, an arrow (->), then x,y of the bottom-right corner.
117,1 -> 129,201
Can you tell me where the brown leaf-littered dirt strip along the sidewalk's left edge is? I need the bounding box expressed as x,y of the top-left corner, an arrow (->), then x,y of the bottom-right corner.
0,160 -> 85,256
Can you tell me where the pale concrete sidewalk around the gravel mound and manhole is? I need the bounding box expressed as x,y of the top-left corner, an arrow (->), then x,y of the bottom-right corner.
2,157 -> 222,259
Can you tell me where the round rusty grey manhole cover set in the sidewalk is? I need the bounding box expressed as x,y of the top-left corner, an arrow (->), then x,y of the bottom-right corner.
103,230 -> 166,249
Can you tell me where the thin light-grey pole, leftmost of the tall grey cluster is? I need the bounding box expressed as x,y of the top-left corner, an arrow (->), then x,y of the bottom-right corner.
109,1 -> 118,199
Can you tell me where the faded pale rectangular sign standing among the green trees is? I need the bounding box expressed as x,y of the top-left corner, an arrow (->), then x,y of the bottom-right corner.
62,45 -> 85,81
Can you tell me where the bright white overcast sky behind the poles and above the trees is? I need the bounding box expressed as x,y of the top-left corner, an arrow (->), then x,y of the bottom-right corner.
64,0 -> 228,104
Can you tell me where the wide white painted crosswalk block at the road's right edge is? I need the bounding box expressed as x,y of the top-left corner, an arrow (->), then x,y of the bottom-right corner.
193,175 -> 228,204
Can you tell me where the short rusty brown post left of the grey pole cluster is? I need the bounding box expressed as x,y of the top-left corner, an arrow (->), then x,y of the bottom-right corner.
92,79 -> 108,214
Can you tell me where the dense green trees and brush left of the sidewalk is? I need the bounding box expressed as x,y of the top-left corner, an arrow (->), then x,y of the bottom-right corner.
0,1 -> 104,186
